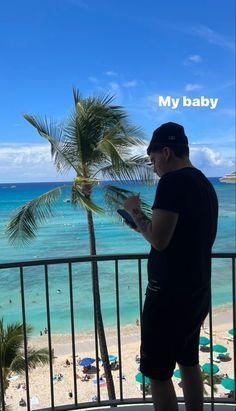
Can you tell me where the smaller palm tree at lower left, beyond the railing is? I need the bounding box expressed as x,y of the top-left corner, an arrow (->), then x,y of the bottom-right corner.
0,319 -> 49,401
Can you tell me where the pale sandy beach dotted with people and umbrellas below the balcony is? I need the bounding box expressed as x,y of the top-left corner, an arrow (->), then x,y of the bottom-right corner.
6,306 -> 234,411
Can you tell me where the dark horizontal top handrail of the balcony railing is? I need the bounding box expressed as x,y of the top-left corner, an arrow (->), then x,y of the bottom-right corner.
0,252 -> 236,269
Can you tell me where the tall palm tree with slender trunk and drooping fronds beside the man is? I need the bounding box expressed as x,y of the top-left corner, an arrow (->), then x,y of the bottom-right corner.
7,89 -> 152,399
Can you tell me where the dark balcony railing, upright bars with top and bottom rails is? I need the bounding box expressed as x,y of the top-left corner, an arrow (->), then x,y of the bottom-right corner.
0,253 -> 236,411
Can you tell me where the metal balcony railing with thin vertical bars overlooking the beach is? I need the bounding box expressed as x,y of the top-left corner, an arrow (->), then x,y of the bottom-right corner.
0,253 -> 236,411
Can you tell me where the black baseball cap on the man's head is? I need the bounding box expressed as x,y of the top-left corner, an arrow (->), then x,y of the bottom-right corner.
147,122 -> 188,154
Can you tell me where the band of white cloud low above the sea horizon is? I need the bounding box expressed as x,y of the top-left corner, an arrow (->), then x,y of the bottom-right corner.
0,142 -> 235,183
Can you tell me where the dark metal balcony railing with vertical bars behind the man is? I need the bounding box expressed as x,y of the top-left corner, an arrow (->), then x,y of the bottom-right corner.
0,252 -> 236,411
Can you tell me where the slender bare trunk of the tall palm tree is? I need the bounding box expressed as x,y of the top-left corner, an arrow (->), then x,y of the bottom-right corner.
87,210 -> 116,400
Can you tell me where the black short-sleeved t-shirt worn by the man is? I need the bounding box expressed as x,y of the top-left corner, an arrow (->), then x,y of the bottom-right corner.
148,167 -> 218,293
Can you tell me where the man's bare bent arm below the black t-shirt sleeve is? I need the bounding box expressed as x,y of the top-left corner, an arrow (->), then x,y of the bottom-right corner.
129,207 -> 179,251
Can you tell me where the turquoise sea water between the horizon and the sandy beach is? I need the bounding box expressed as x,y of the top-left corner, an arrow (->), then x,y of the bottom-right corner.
0,178 -> 236,334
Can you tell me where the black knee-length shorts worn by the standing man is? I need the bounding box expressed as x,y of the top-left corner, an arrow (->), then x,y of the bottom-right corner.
140,287 -> 211,381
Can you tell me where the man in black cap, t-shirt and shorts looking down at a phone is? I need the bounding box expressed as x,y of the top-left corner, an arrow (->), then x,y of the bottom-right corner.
124,122 -> 218,411
